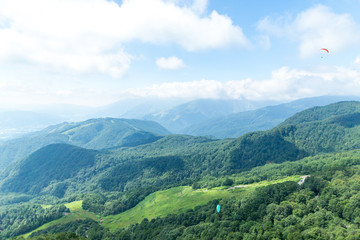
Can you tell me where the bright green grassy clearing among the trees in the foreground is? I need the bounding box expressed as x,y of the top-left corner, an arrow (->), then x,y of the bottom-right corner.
23,176 -> 300,237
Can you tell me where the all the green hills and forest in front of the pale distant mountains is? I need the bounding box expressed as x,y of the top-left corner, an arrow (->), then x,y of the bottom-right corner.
0,98 -> 360,240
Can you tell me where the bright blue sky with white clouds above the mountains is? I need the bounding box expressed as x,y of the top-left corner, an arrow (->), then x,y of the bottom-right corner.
0,0 -> 360,108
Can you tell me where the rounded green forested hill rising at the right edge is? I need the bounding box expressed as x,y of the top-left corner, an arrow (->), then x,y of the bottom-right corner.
279,102 -> 360,154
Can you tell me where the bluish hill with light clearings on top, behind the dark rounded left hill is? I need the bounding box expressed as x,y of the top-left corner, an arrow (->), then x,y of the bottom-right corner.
0,118 -> 170,170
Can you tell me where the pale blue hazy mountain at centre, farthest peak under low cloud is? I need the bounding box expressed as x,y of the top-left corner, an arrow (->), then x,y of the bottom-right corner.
143,99 -> 278,133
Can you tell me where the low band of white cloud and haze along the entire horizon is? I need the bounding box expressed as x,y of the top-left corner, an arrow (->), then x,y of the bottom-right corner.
0,63 -> 360,107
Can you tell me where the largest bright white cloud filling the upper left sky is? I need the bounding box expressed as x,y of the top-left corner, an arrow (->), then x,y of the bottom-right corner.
0,0 -> 248,77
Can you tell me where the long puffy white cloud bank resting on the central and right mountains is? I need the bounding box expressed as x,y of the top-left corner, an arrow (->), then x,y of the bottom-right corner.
122,66 -> 360,100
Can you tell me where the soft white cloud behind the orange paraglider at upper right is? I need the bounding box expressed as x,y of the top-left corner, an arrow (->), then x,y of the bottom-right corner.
258,5 -> 360,57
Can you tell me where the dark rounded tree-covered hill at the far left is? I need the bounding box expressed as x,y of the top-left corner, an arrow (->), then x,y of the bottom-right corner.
1,144 -> 96,197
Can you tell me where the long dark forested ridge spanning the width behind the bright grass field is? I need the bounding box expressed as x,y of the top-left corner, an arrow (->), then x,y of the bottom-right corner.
1,102 -> 360,199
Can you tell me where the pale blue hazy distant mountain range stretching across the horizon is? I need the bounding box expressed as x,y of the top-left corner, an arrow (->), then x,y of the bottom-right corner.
0,96 -> 360,141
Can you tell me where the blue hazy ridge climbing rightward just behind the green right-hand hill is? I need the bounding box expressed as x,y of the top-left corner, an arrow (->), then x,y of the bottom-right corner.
183,96 -> 360,138
